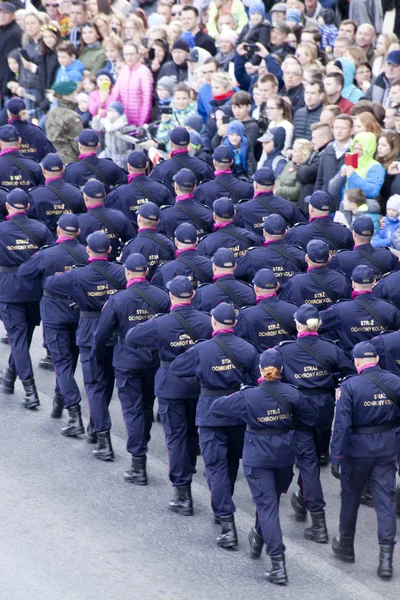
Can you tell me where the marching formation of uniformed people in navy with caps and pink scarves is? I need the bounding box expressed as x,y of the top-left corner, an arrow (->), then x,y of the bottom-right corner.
0,124 -> 400,584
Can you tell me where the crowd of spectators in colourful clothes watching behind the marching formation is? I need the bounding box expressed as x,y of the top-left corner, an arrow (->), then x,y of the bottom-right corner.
0,0 -> 400,248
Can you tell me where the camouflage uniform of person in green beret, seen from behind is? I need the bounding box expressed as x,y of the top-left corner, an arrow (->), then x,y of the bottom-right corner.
46,98 -> 83,165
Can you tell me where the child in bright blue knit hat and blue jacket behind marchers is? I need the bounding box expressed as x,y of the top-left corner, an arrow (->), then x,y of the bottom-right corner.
222,120 -> 257,181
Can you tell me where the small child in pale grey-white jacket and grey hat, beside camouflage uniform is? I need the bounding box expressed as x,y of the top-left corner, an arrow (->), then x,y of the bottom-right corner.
92,102 -> 131,167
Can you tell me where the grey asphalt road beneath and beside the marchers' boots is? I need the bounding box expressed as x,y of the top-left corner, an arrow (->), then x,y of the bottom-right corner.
0,330 -> 400,600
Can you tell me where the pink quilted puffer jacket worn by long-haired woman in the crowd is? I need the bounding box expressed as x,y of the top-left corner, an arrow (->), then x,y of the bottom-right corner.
111,63 -> 153,125
